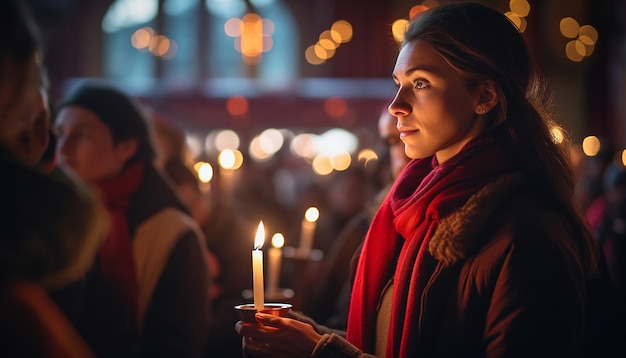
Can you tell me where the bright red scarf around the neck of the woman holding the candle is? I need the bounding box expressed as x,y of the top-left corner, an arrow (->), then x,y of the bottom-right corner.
347,128 -> 513,357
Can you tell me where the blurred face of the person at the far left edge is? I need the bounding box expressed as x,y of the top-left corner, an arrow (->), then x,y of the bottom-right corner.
0,60 -> 50,166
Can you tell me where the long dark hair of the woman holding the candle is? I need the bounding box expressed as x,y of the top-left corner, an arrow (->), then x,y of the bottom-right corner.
401,3 -> 597,272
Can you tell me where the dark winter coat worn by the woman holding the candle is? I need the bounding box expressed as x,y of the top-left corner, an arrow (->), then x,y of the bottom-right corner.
313,177 -> 586,357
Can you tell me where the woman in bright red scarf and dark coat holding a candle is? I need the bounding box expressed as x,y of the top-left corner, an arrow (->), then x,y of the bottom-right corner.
236,3 -> 596,357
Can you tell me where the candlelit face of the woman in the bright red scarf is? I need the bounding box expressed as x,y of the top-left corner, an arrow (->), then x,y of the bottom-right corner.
389,40 -> 485,163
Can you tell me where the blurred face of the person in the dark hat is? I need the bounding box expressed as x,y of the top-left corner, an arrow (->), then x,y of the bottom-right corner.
55,106 -> 134,183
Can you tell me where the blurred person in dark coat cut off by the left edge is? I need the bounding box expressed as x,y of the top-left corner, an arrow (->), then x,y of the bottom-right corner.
0,0 -> 106,358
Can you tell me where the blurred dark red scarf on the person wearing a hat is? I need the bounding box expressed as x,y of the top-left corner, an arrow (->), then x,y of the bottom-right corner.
98,163 -> 144,337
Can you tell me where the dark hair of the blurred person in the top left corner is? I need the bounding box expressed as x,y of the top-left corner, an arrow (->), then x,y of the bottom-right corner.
0,0 -> 43,119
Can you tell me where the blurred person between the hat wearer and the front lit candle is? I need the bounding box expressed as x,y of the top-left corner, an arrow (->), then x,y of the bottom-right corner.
165,160 -> 255,358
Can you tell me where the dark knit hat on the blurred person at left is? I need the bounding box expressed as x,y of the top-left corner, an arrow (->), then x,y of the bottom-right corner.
58,82 -> 154,159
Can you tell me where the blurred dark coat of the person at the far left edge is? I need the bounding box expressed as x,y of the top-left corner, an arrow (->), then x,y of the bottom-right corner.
0,153 -> 108,358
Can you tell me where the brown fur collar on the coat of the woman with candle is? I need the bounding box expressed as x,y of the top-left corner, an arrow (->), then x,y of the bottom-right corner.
428,173 -> 525,266
